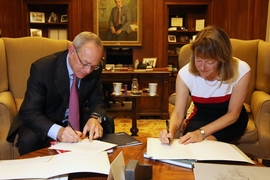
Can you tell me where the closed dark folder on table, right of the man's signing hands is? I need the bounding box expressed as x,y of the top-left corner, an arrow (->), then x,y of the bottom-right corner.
100,132 -> 142,147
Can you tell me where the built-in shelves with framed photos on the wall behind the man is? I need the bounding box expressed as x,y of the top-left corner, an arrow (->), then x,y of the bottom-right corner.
24,0 -> 69,39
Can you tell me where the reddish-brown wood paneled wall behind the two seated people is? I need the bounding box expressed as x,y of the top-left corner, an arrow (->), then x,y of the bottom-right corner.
0,0 -> 268,67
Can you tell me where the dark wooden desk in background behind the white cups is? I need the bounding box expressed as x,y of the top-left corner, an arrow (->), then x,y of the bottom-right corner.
101,70 -> 170,119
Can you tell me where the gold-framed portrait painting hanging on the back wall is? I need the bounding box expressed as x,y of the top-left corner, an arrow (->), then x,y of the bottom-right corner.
93,0 -> 142,47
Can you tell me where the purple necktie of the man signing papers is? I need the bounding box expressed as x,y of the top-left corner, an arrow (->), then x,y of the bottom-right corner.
68,74 -> 80,130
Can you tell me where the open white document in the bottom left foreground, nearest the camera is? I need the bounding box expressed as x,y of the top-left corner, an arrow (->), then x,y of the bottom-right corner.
0,151 -> 110,179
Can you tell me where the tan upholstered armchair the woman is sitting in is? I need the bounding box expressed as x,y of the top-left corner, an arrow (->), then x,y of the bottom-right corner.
169,39 -> 270,165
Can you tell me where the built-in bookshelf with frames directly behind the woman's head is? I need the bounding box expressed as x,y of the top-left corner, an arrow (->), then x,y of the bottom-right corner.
167,4 -> 207,70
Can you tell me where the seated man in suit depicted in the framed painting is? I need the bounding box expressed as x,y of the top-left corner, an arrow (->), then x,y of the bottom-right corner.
107,0 -> 131,41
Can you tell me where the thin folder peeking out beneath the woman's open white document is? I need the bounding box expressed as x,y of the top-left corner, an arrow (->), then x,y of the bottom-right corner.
143,153 -> 196,169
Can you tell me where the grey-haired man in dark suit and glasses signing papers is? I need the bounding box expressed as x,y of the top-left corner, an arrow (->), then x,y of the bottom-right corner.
7,32 -> 114,155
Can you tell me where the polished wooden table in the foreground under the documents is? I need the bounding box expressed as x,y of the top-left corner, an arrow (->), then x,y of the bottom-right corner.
19,137 -> 195,180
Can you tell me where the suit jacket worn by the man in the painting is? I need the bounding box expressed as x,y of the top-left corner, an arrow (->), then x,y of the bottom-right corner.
109,6 -> 131,33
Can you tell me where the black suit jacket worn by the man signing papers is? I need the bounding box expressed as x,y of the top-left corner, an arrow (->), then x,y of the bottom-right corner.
7,51 -> 106,142
